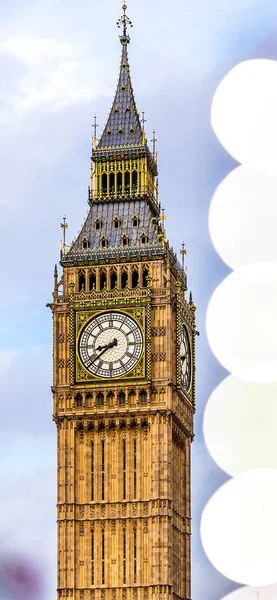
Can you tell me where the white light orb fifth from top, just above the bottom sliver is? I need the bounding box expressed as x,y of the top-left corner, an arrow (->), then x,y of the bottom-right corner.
200,469 -> 277,586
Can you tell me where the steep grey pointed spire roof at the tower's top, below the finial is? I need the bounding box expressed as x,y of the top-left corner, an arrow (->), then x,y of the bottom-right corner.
98,42 -> 144,148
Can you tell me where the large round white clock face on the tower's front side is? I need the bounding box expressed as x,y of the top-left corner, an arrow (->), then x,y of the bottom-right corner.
79,312 -> 142,379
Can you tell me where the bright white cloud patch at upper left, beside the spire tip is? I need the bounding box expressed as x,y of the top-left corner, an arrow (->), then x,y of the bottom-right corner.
0,37 -> 106,120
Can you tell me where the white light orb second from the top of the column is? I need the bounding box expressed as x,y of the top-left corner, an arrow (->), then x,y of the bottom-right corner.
209,167 -> 277,269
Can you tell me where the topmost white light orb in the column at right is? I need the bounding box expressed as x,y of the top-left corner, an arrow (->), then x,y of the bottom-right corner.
211,59 -> 277,175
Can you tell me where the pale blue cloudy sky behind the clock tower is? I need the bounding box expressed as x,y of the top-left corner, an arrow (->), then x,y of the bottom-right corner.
0,0 -> 277,600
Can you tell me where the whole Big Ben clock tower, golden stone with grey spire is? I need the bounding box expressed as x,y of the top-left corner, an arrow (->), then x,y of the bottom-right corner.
51,4 -> 196,600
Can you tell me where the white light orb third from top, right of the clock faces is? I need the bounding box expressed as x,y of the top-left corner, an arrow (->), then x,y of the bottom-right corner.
206,262 -> 277,383
